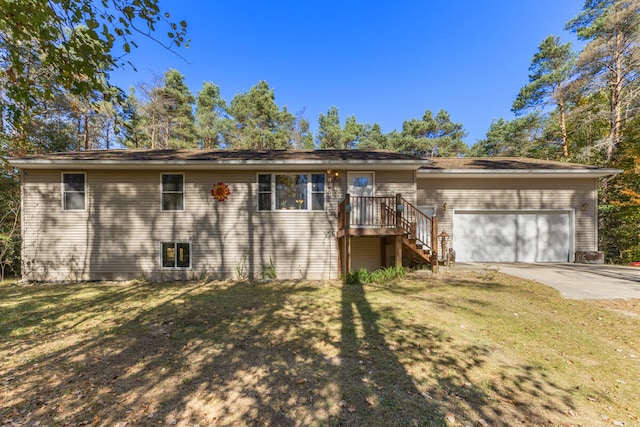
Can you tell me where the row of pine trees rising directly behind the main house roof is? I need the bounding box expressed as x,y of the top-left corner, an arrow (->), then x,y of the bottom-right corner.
0,64 -> 469,157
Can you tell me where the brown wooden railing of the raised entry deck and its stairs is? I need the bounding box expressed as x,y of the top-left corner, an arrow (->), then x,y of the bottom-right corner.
338,194 -> 437,252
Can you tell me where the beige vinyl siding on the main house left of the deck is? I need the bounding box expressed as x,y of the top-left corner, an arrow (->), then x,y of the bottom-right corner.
23,170 -> 342,280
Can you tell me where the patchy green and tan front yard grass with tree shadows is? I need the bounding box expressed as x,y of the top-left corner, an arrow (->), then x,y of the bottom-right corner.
0,271 -> 640,427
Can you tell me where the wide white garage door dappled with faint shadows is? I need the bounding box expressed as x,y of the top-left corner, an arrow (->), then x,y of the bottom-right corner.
453,211 -> 573,262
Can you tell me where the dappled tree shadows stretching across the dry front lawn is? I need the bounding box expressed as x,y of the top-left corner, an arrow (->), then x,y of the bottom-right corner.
0,282 -> 584,426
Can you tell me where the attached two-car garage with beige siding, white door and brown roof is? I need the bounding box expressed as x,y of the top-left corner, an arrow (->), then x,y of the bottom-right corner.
416,157 -> 621,262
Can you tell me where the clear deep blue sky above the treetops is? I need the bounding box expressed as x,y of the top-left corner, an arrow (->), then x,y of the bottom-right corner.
112,0 -> 584,145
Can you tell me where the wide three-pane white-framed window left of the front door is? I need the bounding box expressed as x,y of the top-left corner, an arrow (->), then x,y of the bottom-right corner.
258,173 -> 325,211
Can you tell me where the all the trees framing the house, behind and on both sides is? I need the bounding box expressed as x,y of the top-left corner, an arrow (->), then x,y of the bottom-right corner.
0,0 -> 640,278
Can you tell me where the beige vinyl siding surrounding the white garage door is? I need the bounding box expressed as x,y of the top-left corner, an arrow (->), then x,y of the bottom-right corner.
417,178 -> 598,251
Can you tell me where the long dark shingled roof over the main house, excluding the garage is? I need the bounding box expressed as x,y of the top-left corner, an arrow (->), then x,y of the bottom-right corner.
15,149 -> 426,163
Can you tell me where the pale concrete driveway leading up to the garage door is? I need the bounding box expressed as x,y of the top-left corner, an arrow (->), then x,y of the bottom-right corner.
456,263 -> 640,299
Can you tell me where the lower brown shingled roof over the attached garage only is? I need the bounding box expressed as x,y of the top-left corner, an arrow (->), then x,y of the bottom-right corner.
420,157 -> 601,171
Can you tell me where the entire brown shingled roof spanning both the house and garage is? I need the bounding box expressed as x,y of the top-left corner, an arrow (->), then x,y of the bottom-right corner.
9,149 -> 621,176
